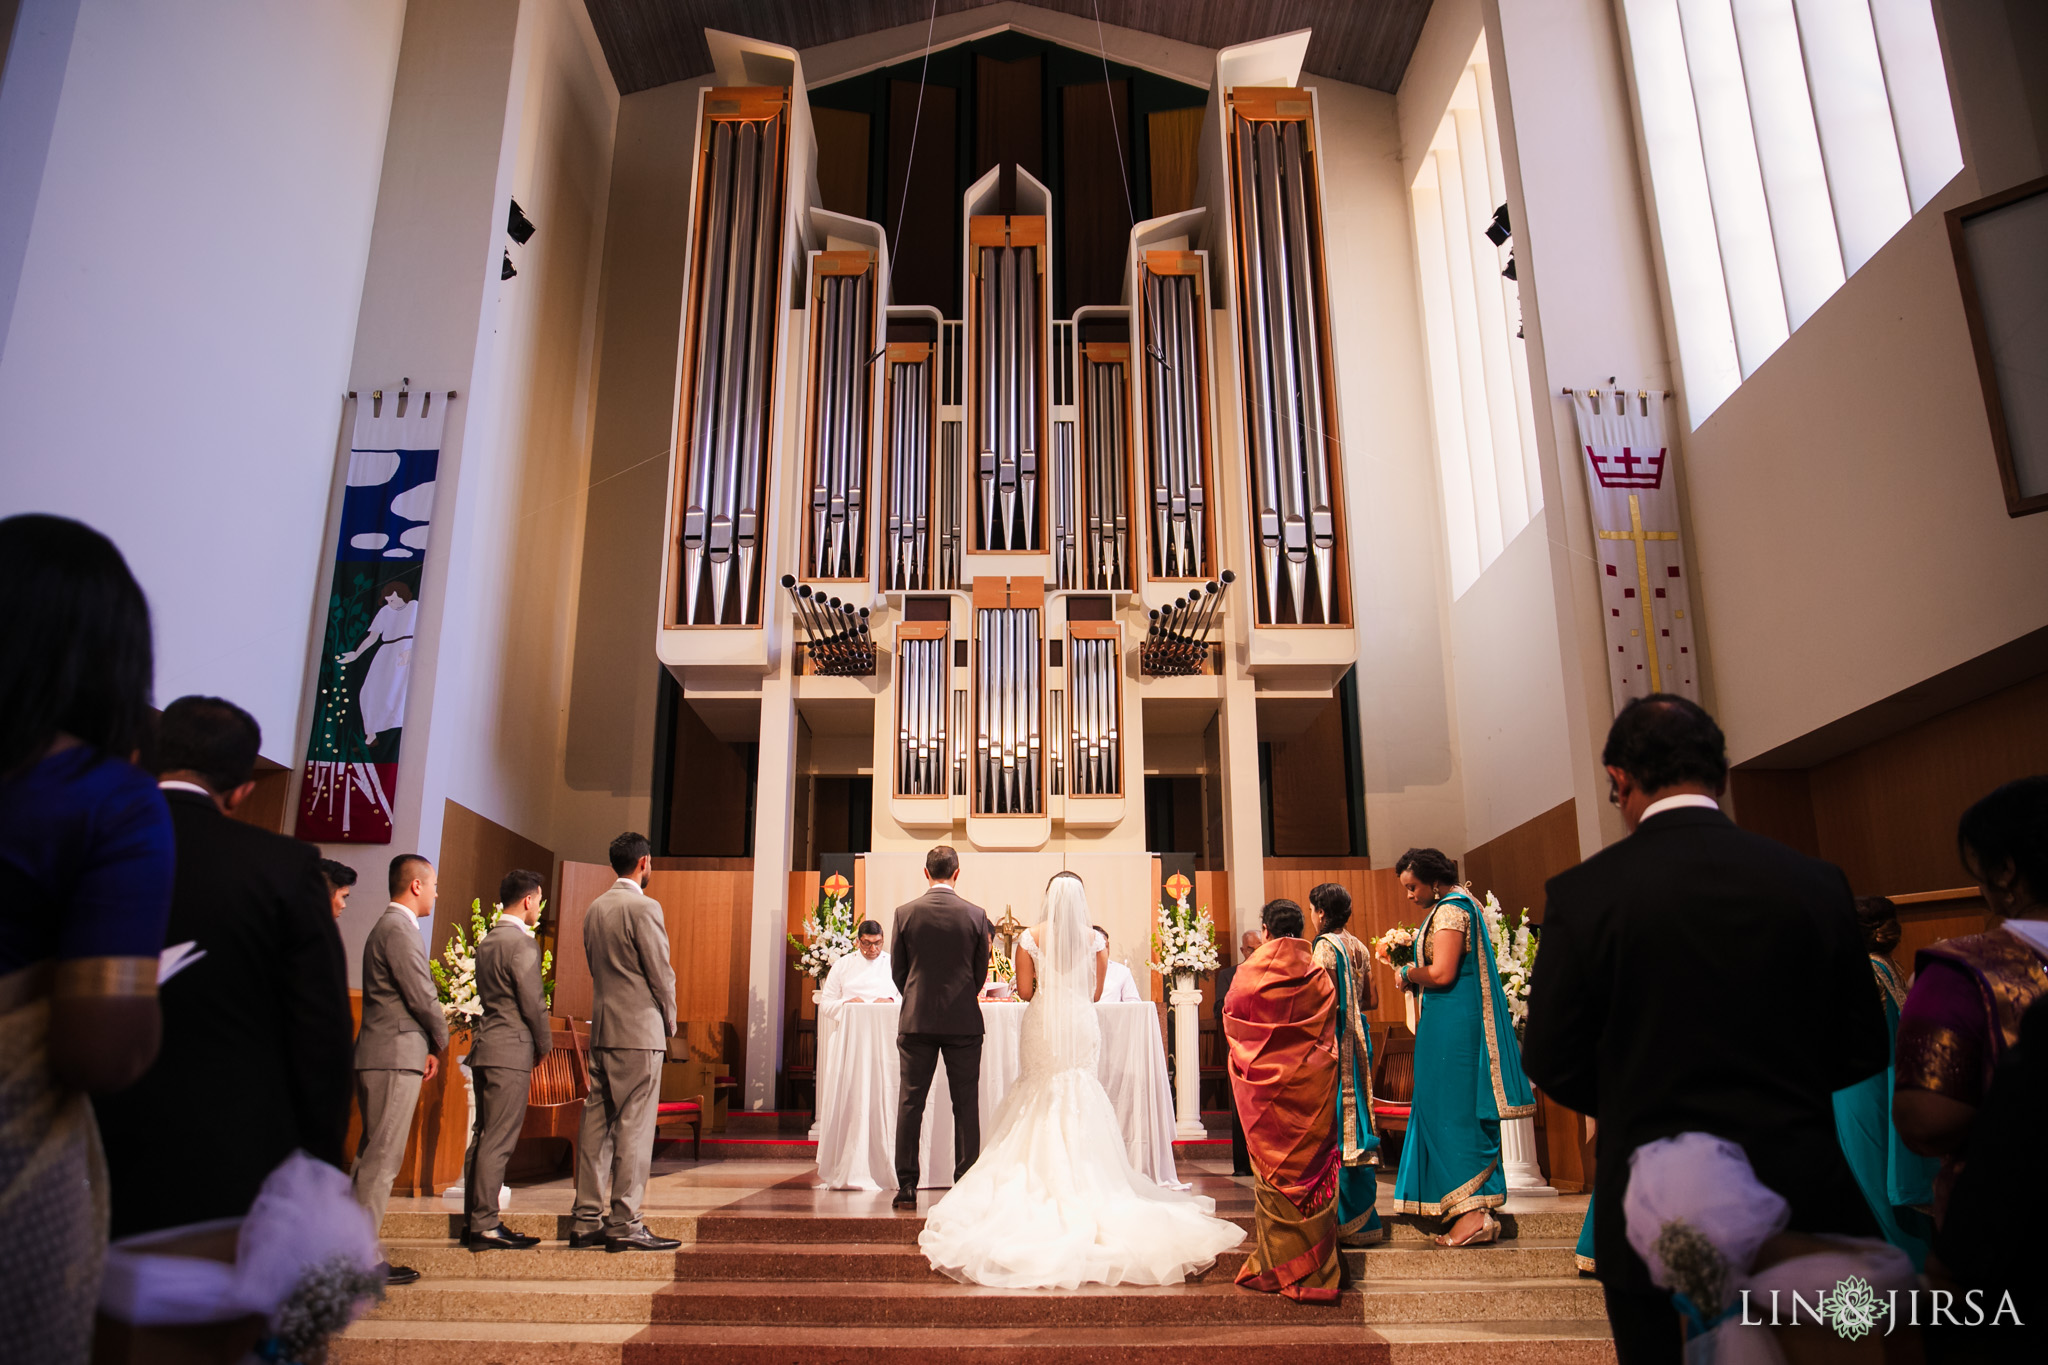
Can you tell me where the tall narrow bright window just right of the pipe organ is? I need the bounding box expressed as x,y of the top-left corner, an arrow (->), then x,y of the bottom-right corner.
1409,39 -> 1542,593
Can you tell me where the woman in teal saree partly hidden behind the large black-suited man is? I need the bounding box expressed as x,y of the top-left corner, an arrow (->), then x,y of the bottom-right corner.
1835,896 -> 1942,1271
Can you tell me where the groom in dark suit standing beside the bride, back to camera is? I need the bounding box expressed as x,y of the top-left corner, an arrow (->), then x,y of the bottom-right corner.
889,843 -> 989,1209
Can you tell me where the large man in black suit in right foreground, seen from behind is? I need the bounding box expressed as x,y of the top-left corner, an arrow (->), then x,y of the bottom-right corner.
1522,694 -> 1888,1365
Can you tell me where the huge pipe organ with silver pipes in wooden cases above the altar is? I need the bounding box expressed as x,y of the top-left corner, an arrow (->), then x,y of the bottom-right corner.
657,35 -> 1356,888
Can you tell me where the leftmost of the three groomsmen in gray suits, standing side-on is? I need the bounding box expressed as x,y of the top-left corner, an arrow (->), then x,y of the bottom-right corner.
354,853 -> 449,1285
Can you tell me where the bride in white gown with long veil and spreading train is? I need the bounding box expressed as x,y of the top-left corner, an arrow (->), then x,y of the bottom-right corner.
918,872 -> 1245,1289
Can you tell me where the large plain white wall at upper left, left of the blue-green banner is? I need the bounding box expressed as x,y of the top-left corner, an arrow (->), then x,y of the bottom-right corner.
0,0 -> 406,765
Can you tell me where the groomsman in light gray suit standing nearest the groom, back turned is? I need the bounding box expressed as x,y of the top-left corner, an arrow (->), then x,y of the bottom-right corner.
569,835 -> 682,1250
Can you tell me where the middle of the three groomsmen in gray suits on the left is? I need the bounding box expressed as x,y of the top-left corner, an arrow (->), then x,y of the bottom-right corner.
463,870 -> 553,1250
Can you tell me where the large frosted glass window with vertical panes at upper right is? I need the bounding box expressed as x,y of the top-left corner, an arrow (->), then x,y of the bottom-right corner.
1622,0 -> 1962,426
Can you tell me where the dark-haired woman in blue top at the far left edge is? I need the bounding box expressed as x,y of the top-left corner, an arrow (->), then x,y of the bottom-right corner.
0,516 -> 172,1365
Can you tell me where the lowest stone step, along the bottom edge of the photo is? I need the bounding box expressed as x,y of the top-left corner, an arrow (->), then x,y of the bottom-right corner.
339,1310 -> 1614,1365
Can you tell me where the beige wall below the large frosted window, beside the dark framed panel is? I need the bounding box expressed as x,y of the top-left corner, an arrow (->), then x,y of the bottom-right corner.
1622,2 -> 2048,761
